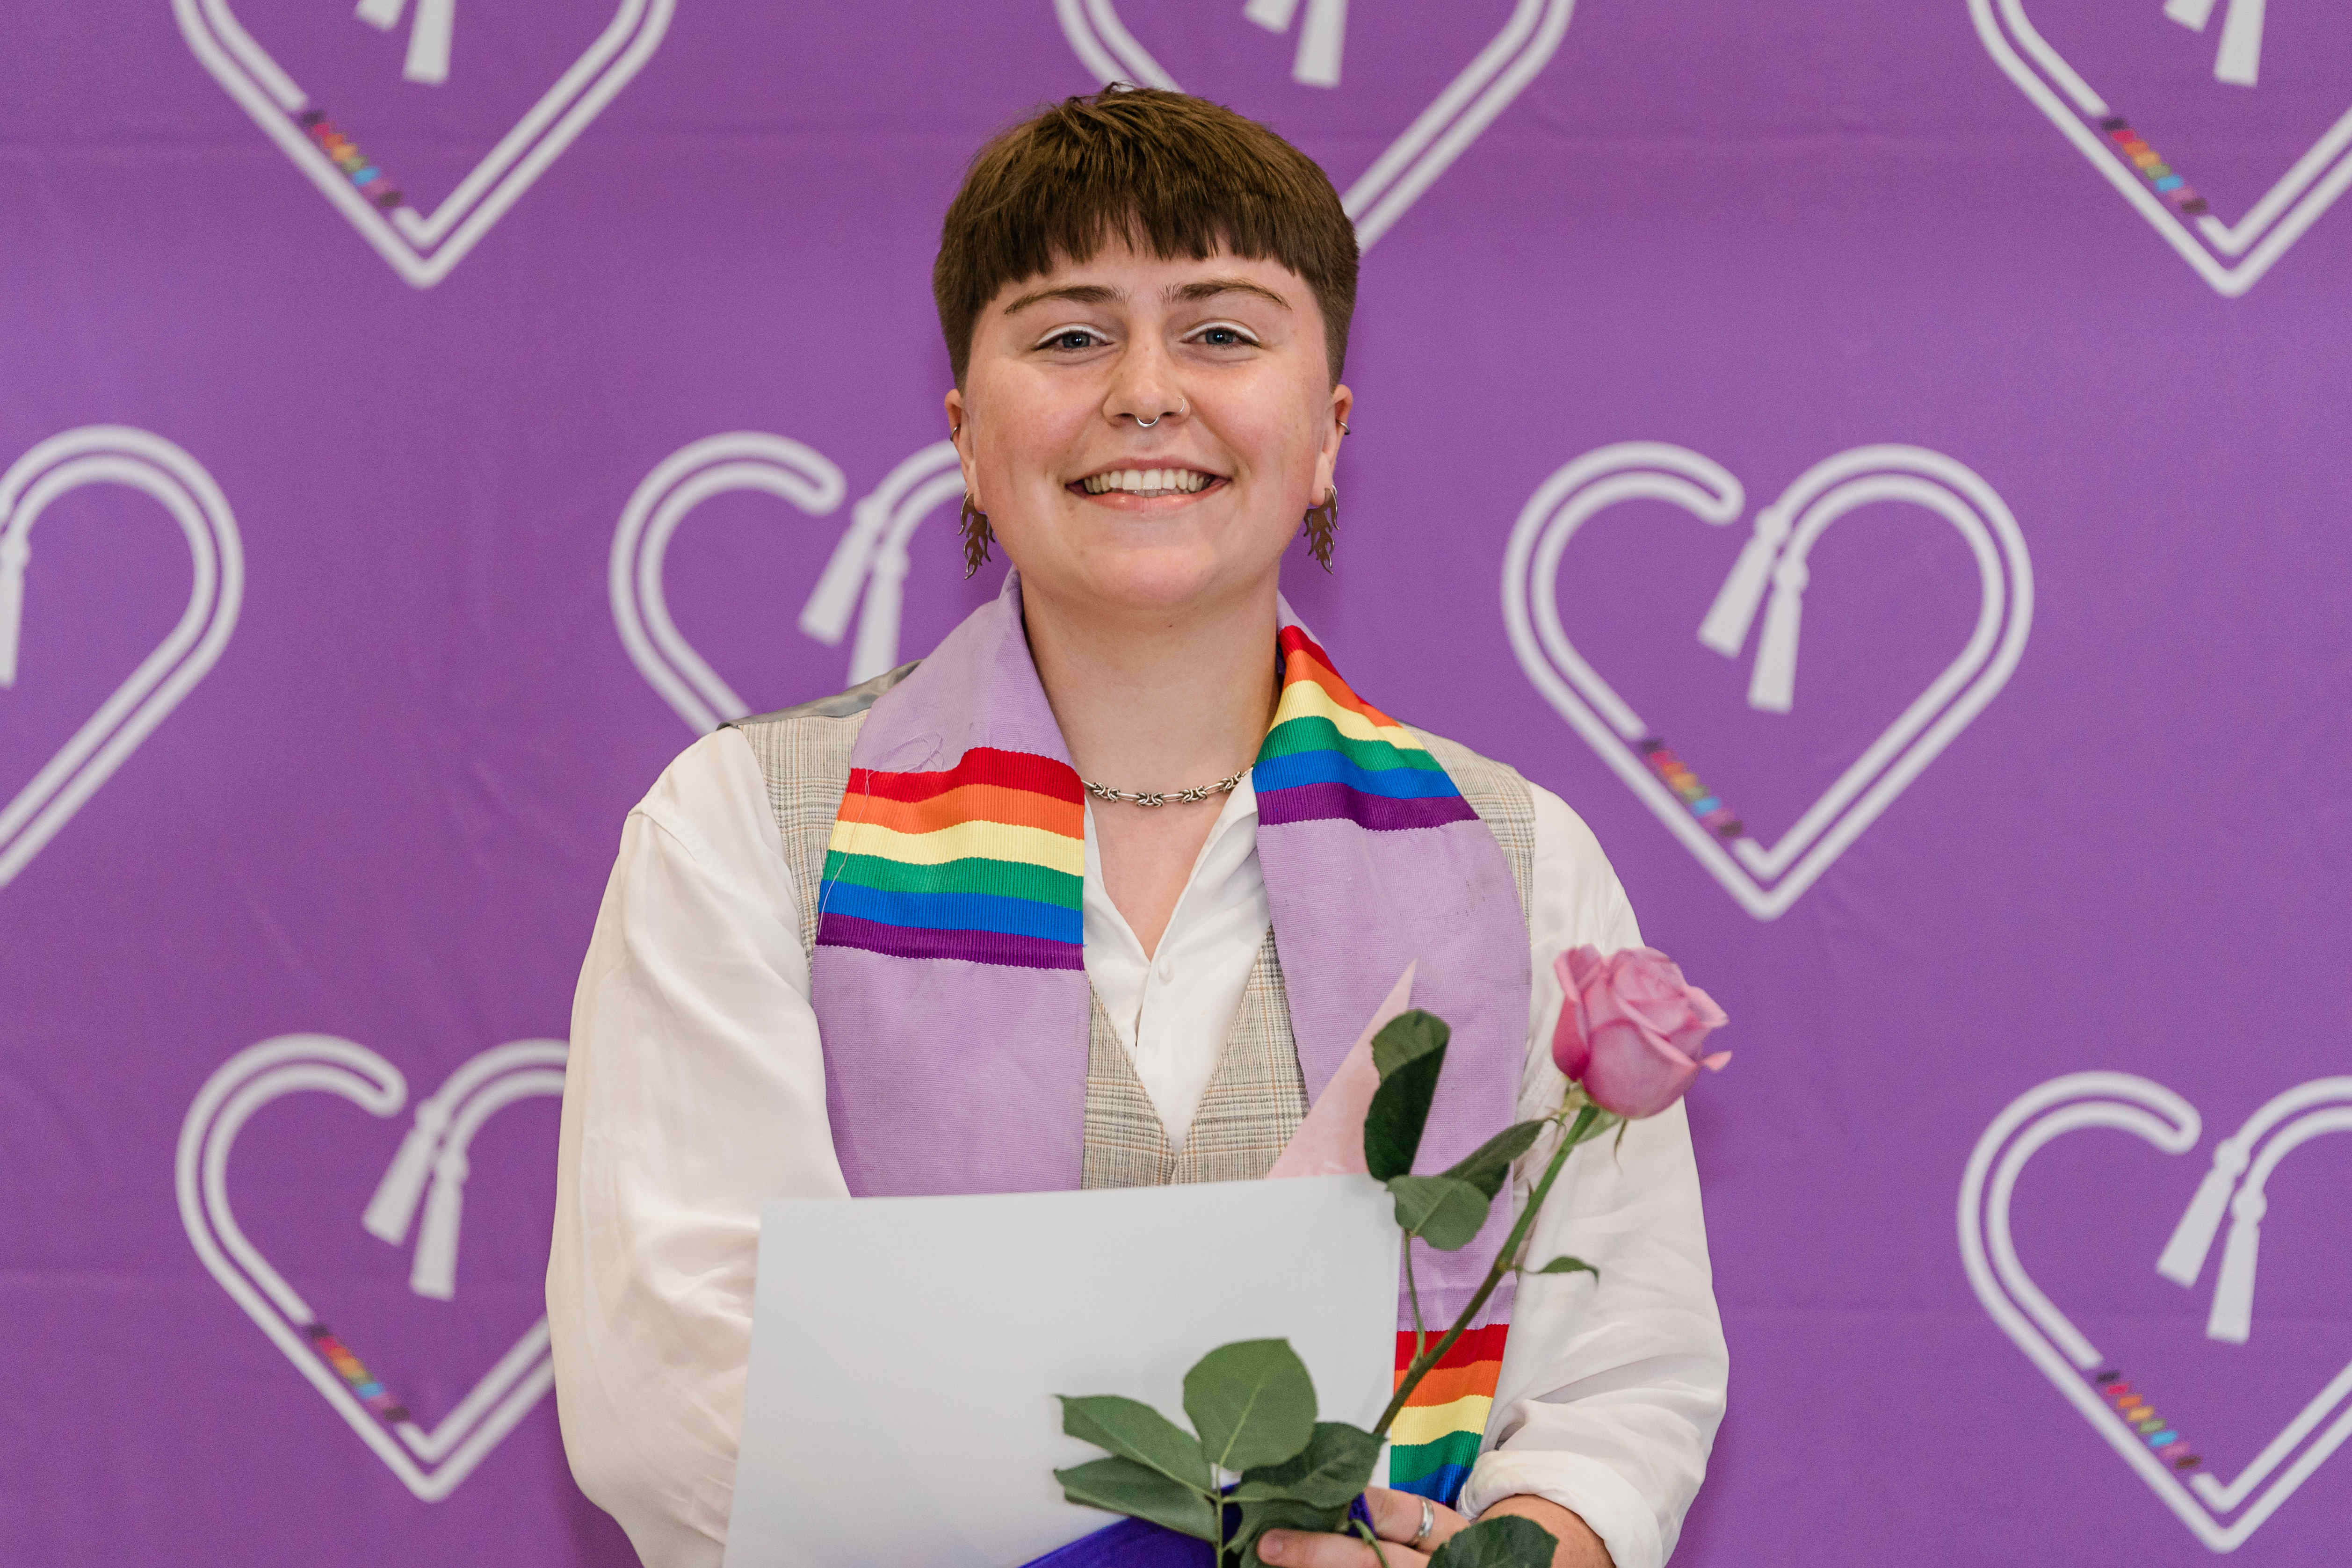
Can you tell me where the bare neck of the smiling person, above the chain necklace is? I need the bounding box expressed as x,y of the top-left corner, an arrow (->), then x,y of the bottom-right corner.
1021,578 -> 1277,790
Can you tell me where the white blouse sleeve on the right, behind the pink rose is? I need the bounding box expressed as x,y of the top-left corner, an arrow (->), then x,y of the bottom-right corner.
1461,788 -> 1729,1568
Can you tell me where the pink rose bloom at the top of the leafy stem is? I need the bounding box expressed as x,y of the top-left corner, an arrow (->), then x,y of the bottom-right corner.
1552,947 -> 1731,1121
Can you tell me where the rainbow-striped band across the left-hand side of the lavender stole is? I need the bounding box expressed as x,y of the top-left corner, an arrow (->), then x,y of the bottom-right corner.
816,745 -> 1086,968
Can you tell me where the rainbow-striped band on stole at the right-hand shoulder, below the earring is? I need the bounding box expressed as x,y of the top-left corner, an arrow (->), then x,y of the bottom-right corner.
1251,625 -> 1477,830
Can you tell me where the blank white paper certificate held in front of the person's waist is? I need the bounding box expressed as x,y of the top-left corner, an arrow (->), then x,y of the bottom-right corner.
727,1175 -> 1399,1568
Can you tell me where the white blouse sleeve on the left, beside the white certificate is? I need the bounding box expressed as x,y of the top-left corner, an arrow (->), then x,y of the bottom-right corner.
548,731 -> 849,1568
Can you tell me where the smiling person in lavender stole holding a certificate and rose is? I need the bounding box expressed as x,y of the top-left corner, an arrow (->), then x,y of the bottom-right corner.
548,89 -> 1726,1568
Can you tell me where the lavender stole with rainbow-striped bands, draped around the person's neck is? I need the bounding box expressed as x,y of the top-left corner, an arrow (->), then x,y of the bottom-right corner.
811,574 -> 1531,1326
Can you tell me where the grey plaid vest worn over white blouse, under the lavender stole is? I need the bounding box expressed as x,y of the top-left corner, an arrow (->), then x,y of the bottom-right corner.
729,665 -> 1536,1187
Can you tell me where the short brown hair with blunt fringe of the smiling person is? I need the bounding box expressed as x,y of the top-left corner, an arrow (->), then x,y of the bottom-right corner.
931,87 -> 1355,385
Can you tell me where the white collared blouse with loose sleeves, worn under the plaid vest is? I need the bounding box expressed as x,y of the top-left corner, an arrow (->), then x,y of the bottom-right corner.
548,729 -> 1726,1568
